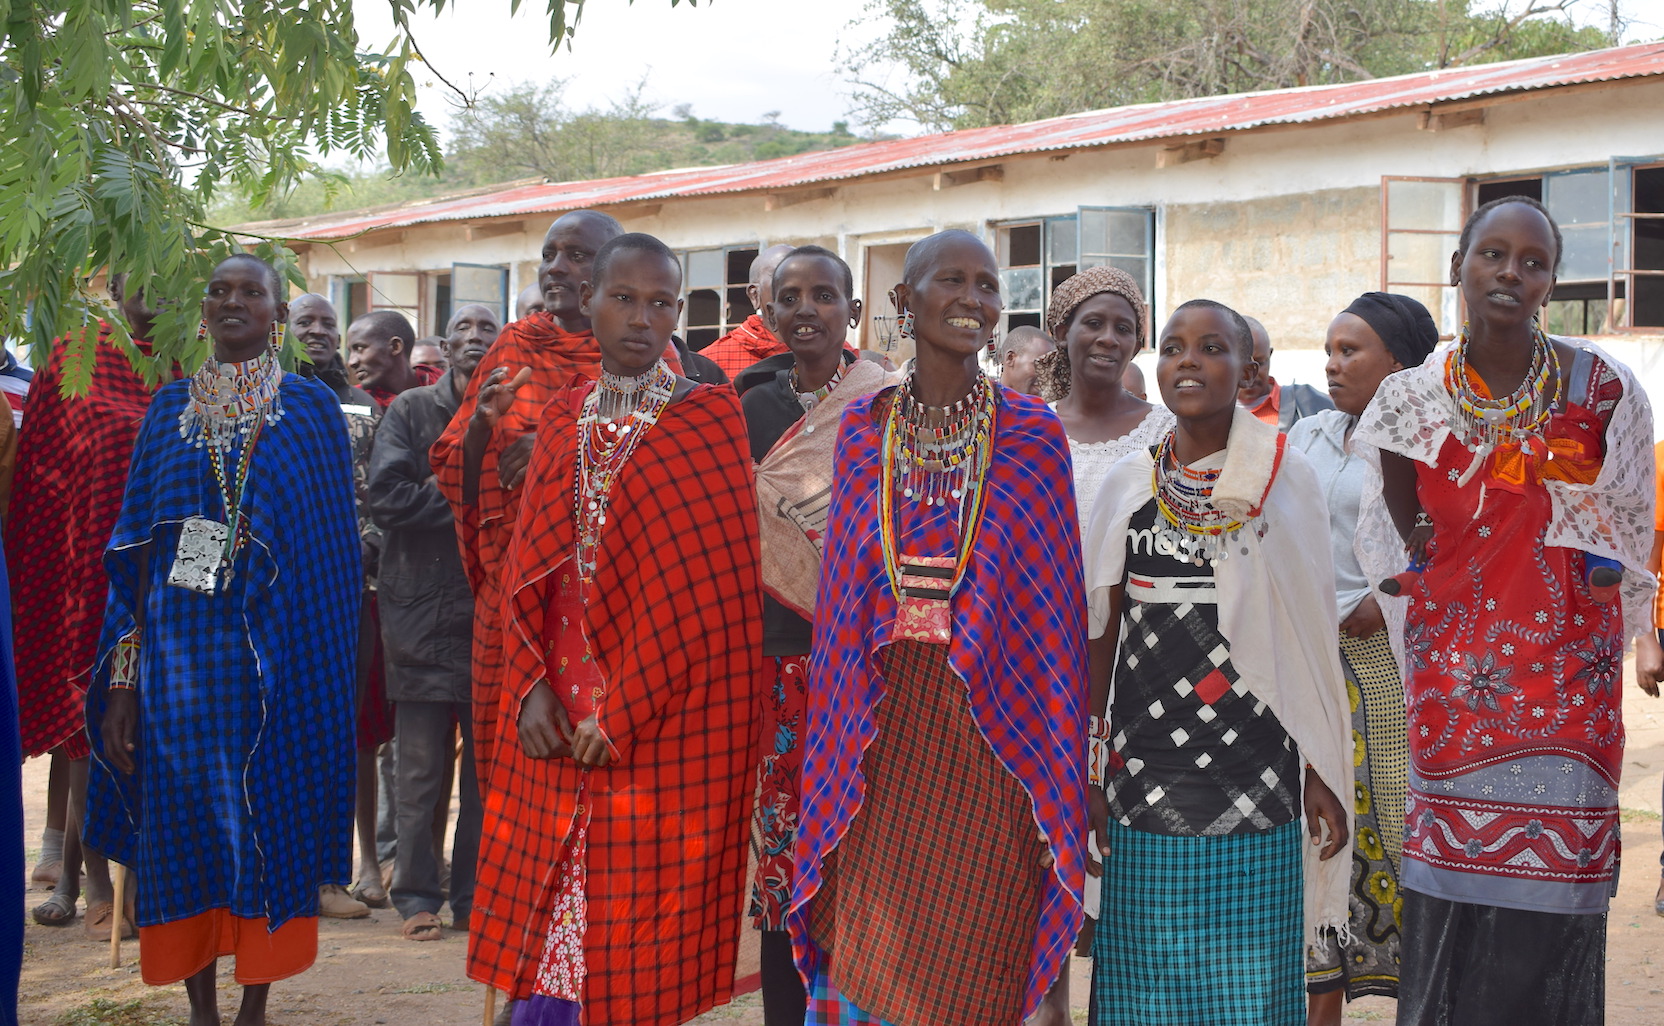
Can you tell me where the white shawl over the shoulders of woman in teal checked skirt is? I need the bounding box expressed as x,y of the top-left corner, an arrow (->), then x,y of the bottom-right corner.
1085,409 -> 1353,941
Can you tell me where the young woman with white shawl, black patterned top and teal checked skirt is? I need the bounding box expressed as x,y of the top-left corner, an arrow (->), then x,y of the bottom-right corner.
1085,299 -> 1351,1026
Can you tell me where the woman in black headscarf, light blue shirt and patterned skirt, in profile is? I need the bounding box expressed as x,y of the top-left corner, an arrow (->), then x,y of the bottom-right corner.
1288,293 -> 1439,1026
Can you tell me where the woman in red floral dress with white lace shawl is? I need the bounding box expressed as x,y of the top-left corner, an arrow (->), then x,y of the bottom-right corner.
1356,196 -> 1652,1026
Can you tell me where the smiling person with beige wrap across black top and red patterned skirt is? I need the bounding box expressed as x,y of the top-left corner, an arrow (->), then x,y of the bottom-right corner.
734,246 -> 899,1026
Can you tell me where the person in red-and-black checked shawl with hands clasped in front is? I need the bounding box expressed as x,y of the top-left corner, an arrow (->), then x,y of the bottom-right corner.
468,234 -> 762,1026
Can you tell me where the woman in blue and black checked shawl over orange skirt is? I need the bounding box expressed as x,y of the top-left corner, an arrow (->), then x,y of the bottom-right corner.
85,254 -> 359,1024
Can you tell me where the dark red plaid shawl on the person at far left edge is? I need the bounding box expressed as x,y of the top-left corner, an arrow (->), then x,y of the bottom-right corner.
5,323 -> 168,758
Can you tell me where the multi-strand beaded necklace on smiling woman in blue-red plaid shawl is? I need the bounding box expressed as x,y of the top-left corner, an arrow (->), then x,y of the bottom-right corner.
879,372 -> 998,602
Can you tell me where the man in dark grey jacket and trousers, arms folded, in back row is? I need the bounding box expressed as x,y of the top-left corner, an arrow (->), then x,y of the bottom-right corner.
369,304 -> 501,941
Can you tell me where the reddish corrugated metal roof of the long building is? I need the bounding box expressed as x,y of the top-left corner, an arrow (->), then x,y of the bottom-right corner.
259,43 -> 1664,241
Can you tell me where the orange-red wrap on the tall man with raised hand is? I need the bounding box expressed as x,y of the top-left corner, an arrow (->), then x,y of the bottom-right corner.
429,313 -> 601,782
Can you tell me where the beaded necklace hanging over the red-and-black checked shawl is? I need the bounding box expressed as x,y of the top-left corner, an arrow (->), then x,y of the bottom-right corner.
572,359 -> 676,585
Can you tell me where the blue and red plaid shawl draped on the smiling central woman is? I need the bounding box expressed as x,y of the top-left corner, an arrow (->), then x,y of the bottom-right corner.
789,387 -> 1087,1013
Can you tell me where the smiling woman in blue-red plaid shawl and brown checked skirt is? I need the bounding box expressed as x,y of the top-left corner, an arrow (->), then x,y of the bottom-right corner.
787,231 -> 1087,1026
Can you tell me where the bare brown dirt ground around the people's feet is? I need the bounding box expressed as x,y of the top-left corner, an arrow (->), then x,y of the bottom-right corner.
18,668 -> 1664,1026
